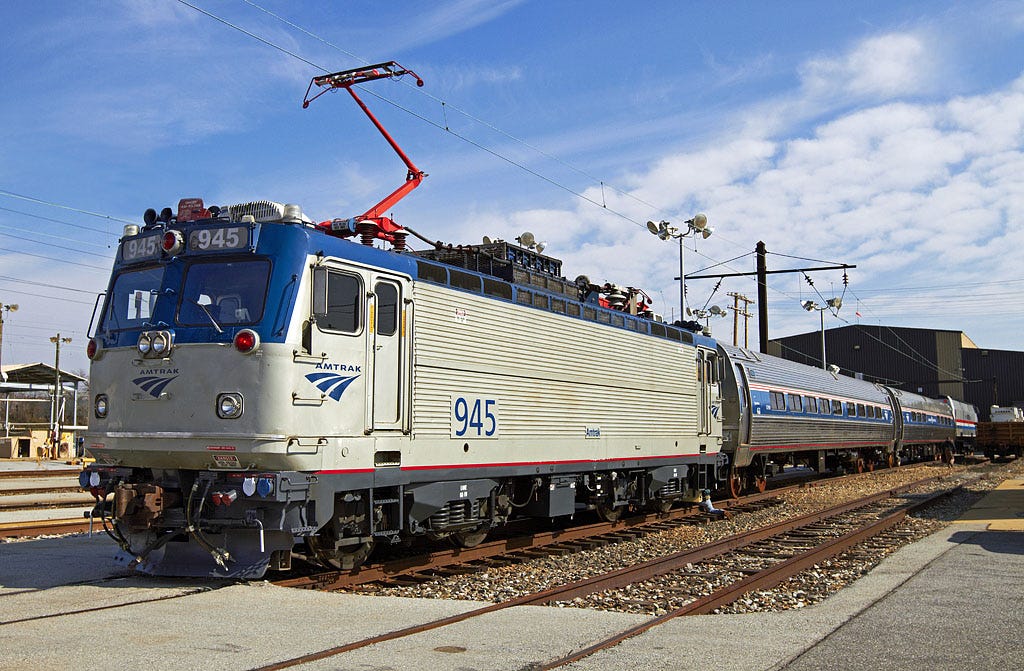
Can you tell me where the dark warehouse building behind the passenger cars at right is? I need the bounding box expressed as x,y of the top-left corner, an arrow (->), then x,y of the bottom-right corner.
768,324 -> 1024,421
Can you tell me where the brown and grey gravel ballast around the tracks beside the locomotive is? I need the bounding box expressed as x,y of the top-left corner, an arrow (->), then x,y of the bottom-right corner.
358,460 -> 1024,615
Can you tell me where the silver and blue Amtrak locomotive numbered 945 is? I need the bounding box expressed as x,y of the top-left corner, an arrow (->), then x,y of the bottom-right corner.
82,199 -> 725,578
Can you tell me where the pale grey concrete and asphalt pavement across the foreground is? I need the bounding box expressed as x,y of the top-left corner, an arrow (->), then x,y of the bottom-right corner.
0,480 -> 1024,671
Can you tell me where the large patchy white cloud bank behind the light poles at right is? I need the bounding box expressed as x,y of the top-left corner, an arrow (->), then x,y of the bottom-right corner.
442,34 -> 1024,347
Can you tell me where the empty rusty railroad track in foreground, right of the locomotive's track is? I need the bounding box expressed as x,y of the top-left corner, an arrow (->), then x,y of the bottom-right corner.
254,477 -> 958,671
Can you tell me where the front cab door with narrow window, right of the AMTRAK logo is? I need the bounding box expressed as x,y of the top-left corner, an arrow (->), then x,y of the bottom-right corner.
367,274 -> 409,431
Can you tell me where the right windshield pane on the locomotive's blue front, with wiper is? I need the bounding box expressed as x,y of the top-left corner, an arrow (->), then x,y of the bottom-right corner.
177,259 -> 270,328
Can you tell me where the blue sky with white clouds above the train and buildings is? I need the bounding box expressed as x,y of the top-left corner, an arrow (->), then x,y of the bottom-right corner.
0,0 -> 1024,370
